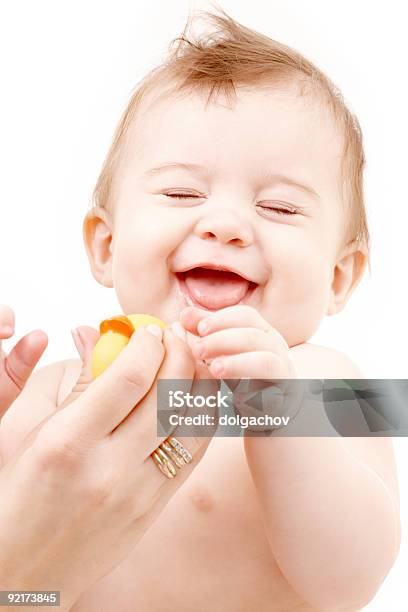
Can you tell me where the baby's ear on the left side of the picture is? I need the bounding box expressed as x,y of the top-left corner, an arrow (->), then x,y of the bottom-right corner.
83,206 -> 113,287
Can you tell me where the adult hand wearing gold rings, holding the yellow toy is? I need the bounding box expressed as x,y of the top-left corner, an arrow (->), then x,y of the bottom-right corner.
0,328 -> 216,610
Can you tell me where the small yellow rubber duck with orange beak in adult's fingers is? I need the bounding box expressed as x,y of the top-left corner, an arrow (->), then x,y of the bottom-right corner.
92,314 -> 167,378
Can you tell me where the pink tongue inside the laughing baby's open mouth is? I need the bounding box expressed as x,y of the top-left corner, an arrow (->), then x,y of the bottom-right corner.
184,268 -> 249,310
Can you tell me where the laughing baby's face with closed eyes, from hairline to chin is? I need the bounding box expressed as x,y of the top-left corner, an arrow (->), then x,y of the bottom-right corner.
91,89 -> 352,346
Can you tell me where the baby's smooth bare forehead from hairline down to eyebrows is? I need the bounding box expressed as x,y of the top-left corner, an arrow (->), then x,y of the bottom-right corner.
124,80 -> 343,191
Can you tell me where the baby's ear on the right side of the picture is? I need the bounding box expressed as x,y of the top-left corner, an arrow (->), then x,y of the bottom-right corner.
327,241 -> 368,315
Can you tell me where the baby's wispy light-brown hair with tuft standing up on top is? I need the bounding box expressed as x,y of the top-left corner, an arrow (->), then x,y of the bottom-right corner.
92,3 -> 370,256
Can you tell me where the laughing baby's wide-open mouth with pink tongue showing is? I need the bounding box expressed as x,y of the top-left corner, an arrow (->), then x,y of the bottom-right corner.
176,267 -> 258,310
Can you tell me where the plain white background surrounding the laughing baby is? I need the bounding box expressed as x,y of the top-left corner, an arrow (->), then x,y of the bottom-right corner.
0,0 -> 408,612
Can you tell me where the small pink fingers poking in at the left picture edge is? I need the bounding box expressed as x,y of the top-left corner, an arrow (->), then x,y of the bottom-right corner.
0,304 -> 48,419
